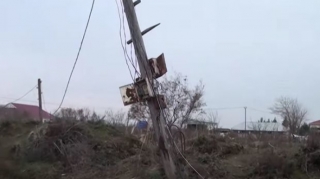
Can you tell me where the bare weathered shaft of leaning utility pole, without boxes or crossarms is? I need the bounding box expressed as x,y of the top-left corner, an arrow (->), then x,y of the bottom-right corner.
122,0 -> 177,179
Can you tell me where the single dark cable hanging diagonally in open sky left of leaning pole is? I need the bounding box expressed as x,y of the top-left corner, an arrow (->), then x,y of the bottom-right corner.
53,0 -> 95,114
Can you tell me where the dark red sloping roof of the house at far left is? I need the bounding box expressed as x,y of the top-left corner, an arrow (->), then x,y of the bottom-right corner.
11,103 -> 52,119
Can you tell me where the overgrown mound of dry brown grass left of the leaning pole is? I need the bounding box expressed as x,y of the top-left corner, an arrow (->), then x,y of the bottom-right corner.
0,121 -> 161,179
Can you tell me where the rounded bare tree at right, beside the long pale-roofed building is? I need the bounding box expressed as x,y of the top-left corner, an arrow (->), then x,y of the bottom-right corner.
270,97 -> 308,134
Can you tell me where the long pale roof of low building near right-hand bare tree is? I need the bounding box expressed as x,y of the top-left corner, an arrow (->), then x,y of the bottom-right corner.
231,121 -> 285,132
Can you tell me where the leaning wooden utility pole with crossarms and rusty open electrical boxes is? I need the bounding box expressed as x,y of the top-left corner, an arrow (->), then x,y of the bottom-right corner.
120,0 -> 177,179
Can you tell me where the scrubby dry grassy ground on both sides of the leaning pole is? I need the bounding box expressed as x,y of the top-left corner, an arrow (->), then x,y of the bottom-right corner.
0,121 -> 320,179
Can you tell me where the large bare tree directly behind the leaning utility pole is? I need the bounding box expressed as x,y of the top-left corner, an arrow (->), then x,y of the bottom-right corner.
128,73 -> 206,126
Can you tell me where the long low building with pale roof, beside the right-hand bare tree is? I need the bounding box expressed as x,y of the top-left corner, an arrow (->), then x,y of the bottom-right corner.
231,122 -> 286,133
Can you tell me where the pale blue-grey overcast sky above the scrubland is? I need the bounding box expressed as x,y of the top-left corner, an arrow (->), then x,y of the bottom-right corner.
0,0 -> 320,127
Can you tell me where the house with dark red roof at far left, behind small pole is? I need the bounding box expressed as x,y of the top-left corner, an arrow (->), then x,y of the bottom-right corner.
0,103 -> 53,122
